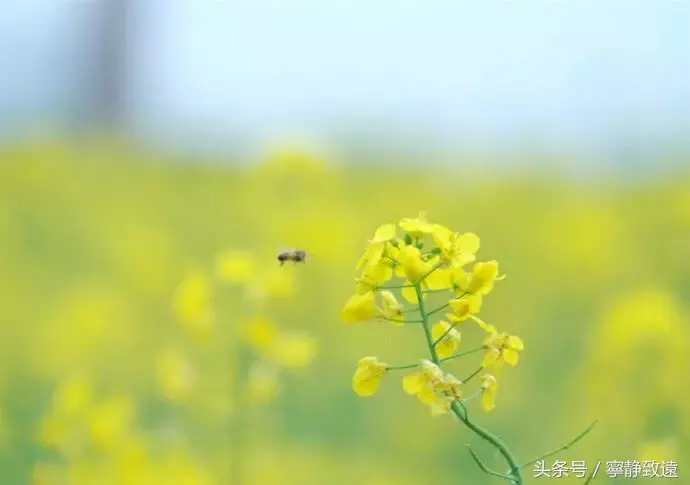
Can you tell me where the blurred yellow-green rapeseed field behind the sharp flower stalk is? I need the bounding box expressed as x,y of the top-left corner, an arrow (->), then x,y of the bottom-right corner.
0,138 -> 690,485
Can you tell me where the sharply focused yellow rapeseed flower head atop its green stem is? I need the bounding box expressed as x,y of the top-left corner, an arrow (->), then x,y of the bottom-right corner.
342,213 -> 524,415
